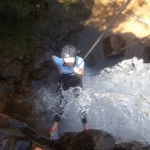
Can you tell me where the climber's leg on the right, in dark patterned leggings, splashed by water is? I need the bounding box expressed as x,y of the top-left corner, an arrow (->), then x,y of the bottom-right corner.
74,87 -> 88,130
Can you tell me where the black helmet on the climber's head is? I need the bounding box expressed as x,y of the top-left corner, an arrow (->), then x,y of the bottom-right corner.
61,45 -> 77,58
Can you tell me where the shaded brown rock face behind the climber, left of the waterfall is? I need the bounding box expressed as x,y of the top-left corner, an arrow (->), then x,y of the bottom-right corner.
0,0 -> 94,133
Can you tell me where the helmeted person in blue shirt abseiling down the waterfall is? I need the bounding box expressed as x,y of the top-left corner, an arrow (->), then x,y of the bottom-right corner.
50,45 -> 88,140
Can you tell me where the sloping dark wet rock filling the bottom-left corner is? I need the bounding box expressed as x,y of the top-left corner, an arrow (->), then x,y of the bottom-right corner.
0,113 -> 54,150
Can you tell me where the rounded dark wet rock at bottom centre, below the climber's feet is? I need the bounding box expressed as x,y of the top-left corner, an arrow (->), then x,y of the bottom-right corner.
54,129 -> 115,150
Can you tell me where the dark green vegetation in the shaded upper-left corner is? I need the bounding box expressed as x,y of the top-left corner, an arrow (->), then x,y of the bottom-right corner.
0,0 -> 39,53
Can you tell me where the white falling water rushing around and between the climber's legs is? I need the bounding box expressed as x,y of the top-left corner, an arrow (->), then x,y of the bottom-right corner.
33,57 -> 150,144
